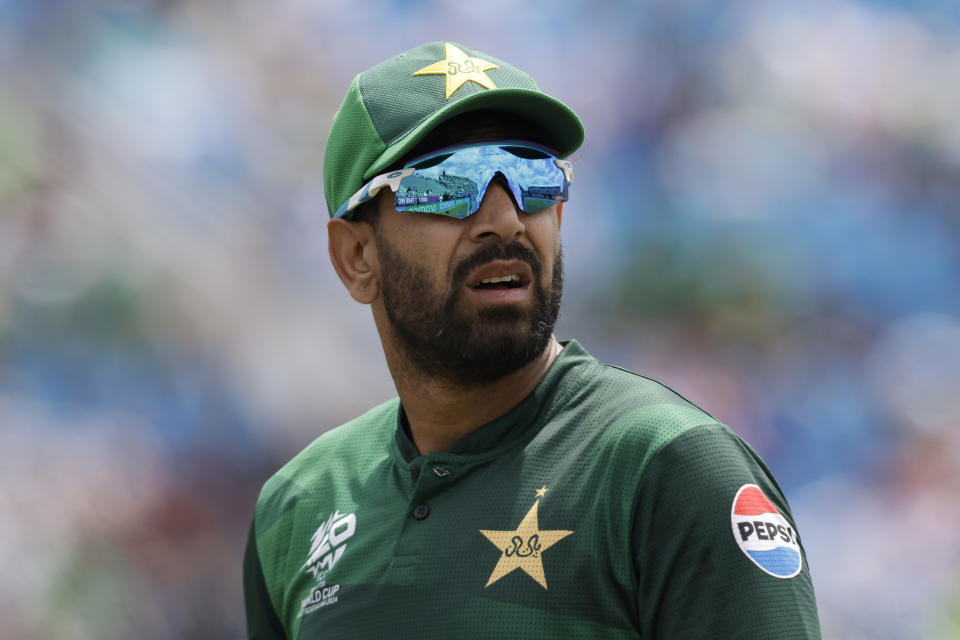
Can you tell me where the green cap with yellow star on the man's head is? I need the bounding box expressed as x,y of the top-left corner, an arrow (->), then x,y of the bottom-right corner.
323,42 -> 583,217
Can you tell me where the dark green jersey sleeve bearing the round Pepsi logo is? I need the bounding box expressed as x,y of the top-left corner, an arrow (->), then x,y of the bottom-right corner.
631,424 -> 820,640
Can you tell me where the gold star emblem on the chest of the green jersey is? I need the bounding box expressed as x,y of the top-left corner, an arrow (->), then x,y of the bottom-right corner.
480,487 -> 573,589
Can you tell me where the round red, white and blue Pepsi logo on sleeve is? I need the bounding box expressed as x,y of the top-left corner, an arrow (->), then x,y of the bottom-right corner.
730,484 -> 803,578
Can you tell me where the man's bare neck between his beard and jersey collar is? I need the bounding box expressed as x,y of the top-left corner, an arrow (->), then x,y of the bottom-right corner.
387,336 -> 563,453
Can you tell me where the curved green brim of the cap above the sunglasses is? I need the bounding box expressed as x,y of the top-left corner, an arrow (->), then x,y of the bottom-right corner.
363,89 -> 583,180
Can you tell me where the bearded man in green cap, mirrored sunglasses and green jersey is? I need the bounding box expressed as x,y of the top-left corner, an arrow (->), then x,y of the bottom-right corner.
244,43 -> 819,640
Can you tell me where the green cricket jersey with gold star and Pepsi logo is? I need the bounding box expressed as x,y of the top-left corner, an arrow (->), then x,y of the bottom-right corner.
244,341 -> 820,640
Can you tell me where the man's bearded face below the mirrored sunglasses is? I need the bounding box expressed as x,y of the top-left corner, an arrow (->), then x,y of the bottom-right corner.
376,168 -> 563,384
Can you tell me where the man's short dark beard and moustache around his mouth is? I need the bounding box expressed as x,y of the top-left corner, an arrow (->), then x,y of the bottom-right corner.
376,235 -> 563,384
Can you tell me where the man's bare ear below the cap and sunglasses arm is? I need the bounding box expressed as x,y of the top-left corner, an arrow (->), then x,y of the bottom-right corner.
327,218 -> 380,304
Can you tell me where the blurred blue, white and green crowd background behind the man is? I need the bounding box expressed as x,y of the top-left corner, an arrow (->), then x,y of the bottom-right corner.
0,0 -> 960,640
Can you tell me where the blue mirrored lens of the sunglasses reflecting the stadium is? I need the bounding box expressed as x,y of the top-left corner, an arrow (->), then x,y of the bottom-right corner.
394,145 -> 568,218
